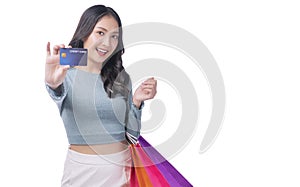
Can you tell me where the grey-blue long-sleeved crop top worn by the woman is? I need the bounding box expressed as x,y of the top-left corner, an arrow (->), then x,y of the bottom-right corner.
46,68 -> 143,145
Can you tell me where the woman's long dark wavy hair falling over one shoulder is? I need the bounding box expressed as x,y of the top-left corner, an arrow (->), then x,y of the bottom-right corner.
69,5 -> 130,98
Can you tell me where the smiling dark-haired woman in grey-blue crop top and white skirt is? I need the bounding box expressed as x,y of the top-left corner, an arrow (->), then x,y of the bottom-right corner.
45,5 -> 157,187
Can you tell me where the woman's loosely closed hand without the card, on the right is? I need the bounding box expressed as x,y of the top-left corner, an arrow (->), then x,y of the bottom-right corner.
132,77 -> 157,108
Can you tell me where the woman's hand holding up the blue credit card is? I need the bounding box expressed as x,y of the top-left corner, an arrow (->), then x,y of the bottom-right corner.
45,42 -> 70,89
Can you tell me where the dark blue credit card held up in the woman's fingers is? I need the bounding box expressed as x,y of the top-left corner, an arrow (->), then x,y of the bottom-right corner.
59,48 -> 87,66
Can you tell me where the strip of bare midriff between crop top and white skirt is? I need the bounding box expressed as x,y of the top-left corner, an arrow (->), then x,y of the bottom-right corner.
70,140 -> 128,155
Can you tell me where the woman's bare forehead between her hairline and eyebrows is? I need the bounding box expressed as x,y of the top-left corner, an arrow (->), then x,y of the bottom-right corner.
94,15 -> 119,32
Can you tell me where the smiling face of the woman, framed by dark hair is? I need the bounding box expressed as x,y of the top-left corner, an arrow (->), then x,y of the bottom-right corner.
83,16 -> 119,64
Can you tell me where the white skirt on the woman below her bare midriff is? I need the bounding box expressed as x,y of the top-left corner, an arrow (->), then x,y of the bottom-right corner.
61,149 -> 131,187
